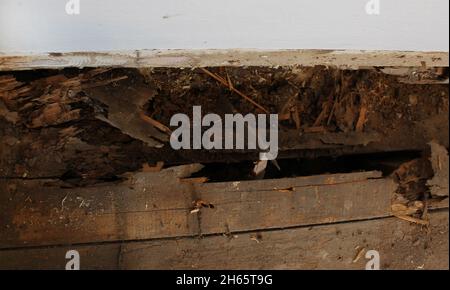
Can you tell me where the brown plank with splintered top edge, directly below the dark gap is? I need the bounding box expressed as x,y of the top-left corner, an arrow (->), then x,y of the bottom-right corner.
0,169 -> 396,248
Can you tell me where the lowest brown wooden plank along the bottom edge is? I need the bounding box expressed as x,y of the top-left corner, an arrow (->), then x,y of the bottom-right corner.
0,210 -> 449,269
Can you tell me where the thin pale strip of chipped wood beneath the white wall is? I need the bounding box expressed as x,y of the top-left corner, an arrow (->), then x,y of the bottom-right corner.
0,49 -> 449,71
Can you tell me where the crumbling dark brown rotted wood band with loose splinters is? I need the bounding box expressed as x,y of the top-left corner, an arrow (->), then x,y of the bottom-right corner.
0,67 -> 449,180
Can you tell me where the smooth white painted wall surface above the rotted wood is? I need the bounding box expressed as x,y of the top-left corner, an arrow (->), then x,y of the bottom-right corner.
0,0 -> 449,53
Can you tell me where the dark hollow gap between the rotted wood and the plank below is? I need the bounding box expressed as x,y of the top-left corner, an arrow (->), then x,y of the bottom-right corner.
3,151 -> 422,187
